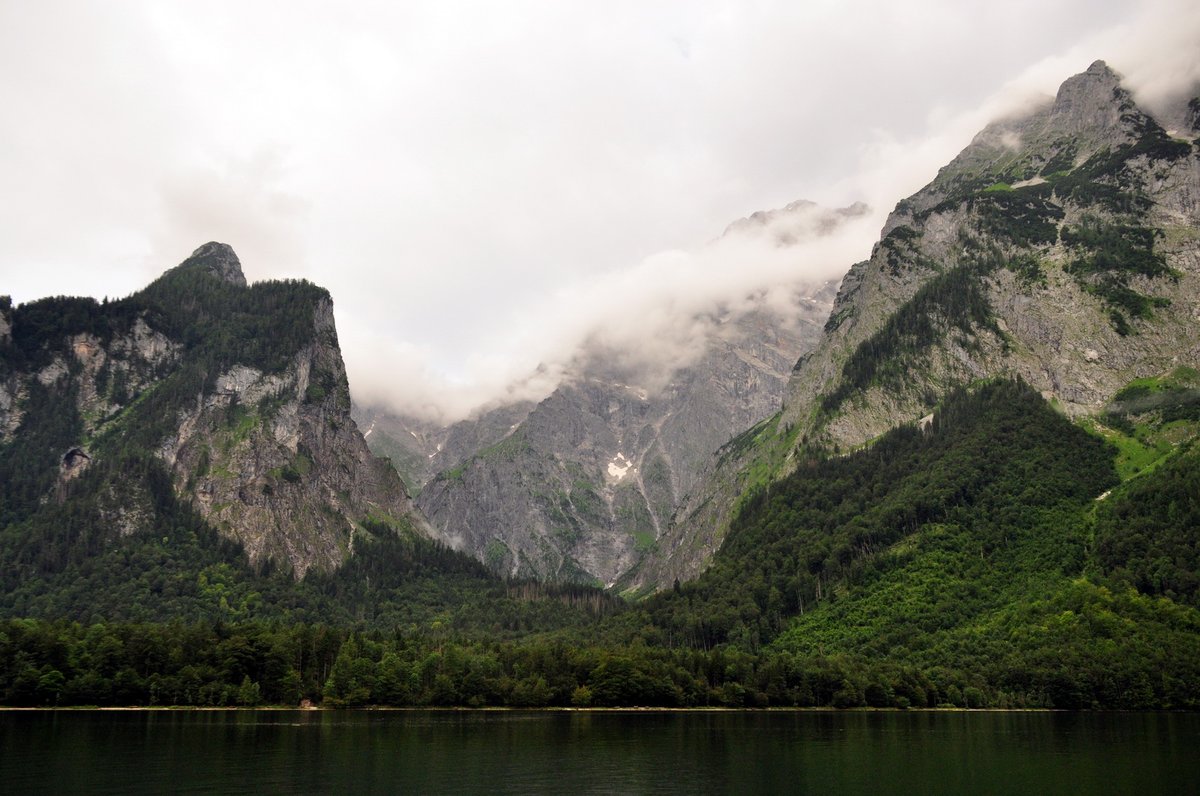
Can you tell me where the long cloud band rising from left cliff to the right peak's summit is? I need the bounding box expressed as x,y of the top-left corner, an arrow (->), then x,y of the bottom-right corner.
343,0 -> 1200,421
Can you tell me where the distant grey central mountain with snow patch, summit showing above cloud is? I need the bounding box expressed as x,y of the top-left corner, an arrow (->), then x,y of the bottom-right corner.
358,202 -> 866,586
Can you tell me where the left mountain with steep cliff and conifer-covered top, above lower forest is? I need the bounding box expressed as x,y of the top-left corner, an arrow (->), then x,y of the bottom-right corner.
0,243 -> 427,583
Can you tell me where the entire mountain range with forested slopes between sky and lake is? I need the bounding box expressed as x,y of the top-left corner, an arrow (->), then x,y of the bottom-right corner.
0,62 -> 1200,710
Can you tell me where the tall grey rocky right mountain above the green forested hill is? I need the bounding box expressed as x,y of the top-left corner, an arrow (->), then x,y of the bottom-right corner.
654,61 -> 1200,588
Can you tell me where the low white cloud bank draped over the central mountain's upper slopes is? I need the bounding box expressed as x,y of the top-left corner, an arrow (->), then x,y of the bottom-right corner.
348,202 -> 883,423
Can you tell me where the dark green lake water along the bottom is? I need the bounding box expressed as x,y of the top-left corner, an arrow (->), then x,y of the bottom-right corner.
0,711 -> 1200,795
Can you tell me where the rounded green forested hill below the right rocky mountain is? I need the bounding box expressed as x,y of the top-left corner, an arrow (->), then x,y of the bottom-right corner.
613,375 -> 1200,710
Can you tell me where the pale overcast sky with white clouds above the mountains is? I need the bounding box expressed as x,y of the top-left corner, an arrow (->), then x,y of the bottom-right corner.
0,0 -> 1200,413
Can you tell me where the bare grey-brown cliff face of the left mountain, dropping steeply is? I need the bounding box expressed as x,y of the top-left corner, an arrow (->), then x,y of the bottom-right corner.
161,292 -> 426,576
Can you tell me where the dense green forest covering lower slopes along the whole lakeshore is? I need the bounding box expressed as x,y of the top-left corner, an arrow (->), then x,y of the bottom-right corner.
0,381 -> 1200,708
